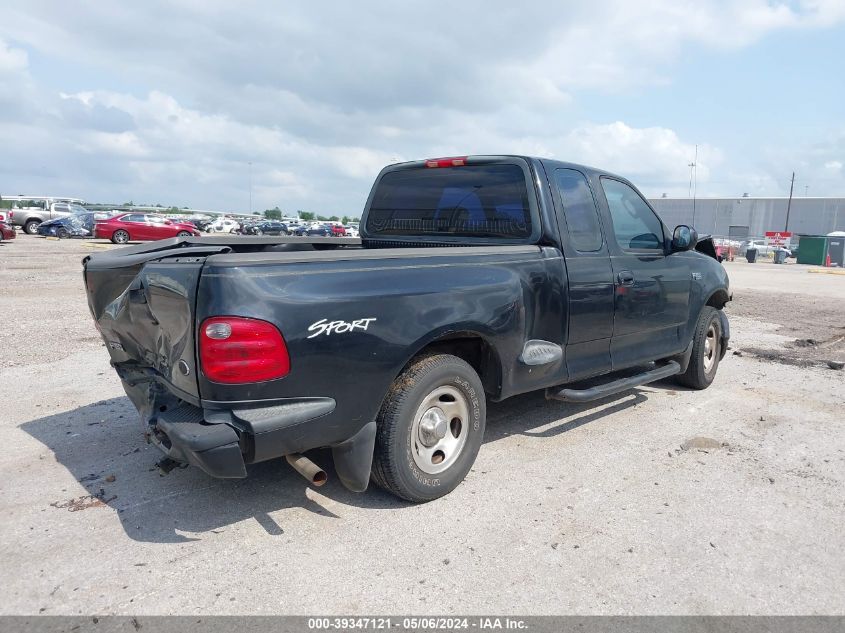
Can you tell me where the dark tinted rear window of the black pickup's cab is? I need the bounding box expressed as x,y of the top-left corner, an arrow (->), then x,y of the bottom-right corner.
367,163 -> 531,238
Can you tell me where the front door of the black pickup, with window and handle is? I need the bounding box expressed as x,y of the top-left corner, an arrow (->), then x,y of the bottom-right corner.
600,176 -> 691,369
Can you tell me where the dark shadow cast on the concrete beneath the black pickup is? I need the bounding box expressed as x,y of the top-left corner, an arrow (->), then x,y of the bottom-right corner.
20,391 -> 646,543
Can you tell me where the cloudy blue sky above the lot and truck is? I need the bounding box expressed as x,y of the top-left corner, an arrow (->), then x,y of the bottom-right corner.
0,0 -> 845,215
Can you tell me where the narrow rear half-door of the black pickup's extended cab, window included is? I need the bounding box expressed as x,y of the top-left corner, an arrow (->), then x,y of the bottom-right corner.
551,169 -> 614,380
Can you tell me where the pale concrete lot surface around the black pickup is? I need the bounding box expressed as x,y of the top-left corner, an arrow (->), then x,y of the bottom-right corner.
0,235 -> 845,614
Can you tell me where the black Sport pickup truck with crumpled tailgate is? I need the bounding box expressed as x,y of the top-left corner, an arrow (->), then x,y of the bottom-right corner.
84,156 -> 731,501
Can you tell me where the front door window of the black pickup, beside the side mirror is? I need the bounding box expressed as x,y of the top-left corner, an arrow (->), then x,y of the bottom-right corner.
601,178 -> 663,251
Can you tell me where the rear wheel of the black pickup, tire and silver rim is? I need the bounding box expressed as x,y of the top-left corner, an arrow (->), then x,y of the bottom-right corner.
372,354 -> 486,502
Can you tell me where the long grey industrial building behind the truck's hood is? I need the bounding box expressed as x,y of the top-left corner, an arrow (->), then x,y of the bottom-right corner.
649,196 -> 845,240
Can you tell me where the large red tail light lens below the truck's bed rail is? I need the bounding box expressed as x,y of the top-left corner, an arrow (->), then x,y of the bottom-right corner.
199,317 -> 290,385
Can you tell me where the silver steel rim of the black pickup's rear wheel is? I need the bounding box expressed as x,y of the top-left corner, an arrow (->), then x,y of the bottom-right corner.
409,385 -> 470,475
